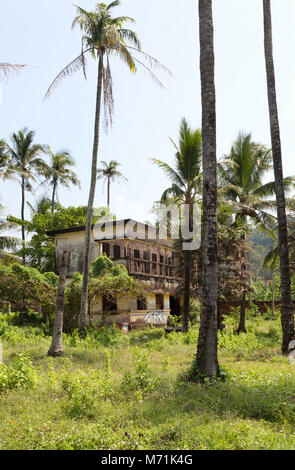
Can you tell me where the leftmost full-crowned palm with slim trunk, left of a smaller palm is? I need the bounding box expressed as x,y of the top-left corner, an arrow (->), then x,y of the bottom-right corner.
4,128 -> 46,260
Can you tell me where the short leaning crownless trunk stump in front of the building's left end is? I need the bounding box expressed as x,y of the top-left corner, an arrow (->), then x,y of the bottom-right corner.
48,251 -> 68,357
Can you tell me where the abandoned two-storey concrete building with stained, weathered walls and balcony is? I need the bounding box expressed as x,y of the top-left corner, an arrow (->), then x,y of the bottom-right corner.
48,219 -> 183,329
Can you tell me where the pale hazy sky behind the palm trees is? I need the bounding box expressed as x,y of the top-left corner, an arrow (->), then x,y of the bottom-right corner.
0,0 -> 295,224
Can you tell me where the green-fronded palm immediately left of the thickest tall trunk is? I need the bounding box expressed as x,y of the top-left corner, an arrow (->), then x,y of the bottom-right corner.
153,119 -> 202,332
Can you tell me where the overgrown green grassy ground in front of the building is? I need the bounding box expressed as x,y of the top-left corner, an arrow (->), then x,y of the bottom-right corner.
0,316 -> 295,450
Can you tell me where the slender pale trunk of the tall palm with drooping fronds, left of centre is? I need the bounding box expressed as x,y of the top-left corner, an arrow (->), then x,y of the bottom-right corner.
79,53 -> 103,332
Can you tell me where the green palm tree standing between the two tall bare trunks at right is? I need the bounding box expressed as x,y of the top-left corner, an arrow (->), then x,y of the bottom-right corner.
219,132 -> 295,333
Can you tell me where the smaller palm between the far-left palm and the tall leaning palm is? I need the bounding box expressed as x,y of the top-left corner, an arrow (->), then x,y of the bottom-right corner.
44,147 -> 80,212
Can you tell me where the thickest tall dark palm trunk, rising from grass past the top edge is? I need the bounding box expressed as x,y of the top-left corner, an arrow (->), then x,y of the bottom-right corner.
196,0 -> 219,377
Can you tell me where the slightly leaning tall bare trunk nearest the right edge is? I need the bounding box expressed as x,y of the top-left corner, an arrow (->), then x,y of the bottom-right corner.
263,0 -> 294,354
